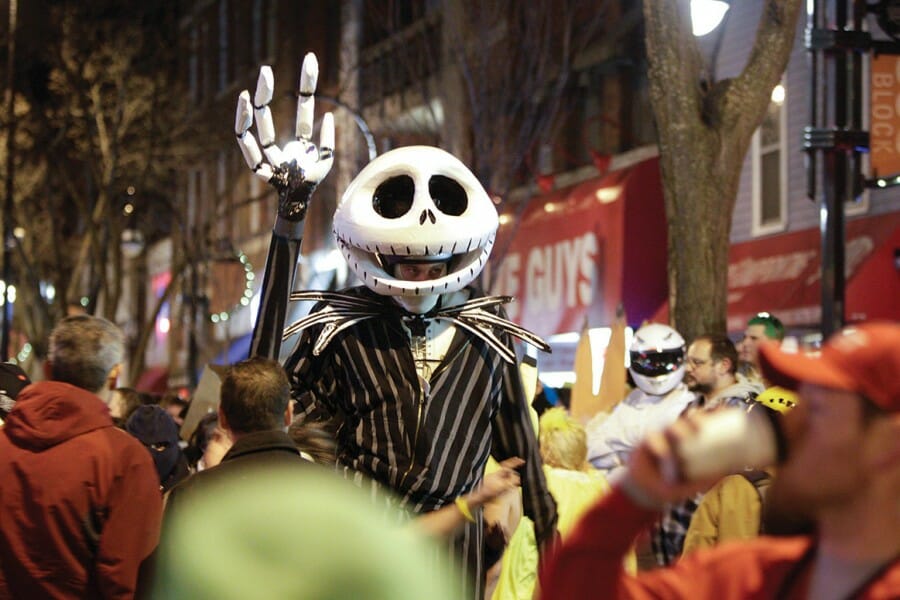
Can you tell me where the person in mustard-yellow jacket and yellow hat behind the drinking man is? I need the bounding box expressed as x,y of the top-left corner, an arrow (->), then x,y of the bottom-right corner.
682,387 -> 797,554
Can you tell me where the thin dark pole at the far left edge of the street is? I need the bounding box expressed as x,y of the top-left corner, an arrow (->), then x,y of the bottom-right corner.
0,0 -> 18,361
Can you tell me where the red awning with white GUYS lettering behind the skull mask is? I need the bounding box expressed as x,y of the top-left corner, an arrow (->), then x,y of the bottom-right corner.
489,158 -> 667,336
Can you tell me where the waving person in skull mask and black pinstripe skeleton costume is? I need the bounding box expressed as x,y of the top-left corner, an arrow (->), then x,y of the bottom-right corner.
235,54 -> 556,598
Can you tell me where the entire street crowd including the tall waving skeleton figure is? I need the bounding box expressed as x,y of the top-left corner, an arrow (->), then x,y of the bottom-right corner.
0,49 -> 900,600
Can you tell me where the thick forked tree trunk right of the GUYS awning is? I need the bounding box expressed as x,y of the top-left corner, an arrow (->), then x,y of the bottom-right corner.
644,0 -> 801,340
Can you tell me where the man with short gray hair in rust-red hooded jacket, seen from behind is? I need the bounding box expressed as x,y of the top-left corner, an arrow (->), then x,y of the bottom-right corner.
0,315 -> 162,598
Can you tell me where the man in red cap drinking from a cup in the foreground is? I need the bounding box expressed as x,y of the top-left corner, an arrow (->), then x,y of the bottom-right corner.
541,322 -> 900,600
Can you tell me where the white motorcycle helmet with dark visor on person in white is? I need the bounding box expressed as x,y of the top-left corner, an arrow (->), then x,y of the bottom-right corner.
628,323 -> 685,396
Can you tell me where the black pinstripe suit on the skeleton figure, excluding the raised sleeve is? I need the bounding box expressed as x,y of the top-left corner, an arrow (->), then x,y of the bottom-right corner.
285,287 -> 556,597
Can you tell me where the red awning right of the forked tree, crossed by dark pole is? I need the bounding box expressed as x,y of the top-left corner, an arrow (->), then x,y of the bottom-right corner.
653,213 -> 900,331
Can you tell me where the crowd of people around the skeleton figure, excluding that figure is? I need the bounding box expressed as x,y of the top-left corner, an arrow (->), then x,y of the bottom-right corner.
0,314 -> 900,600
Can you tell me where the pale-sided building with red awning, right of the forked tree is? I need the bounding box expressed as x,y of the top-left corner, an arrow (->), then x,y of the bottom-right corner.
713,2 -> 900,333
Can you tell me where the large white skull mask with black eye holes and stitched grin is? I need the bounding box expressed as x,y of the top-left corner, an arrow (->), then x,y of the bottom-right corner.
334,146 -> 498,297
